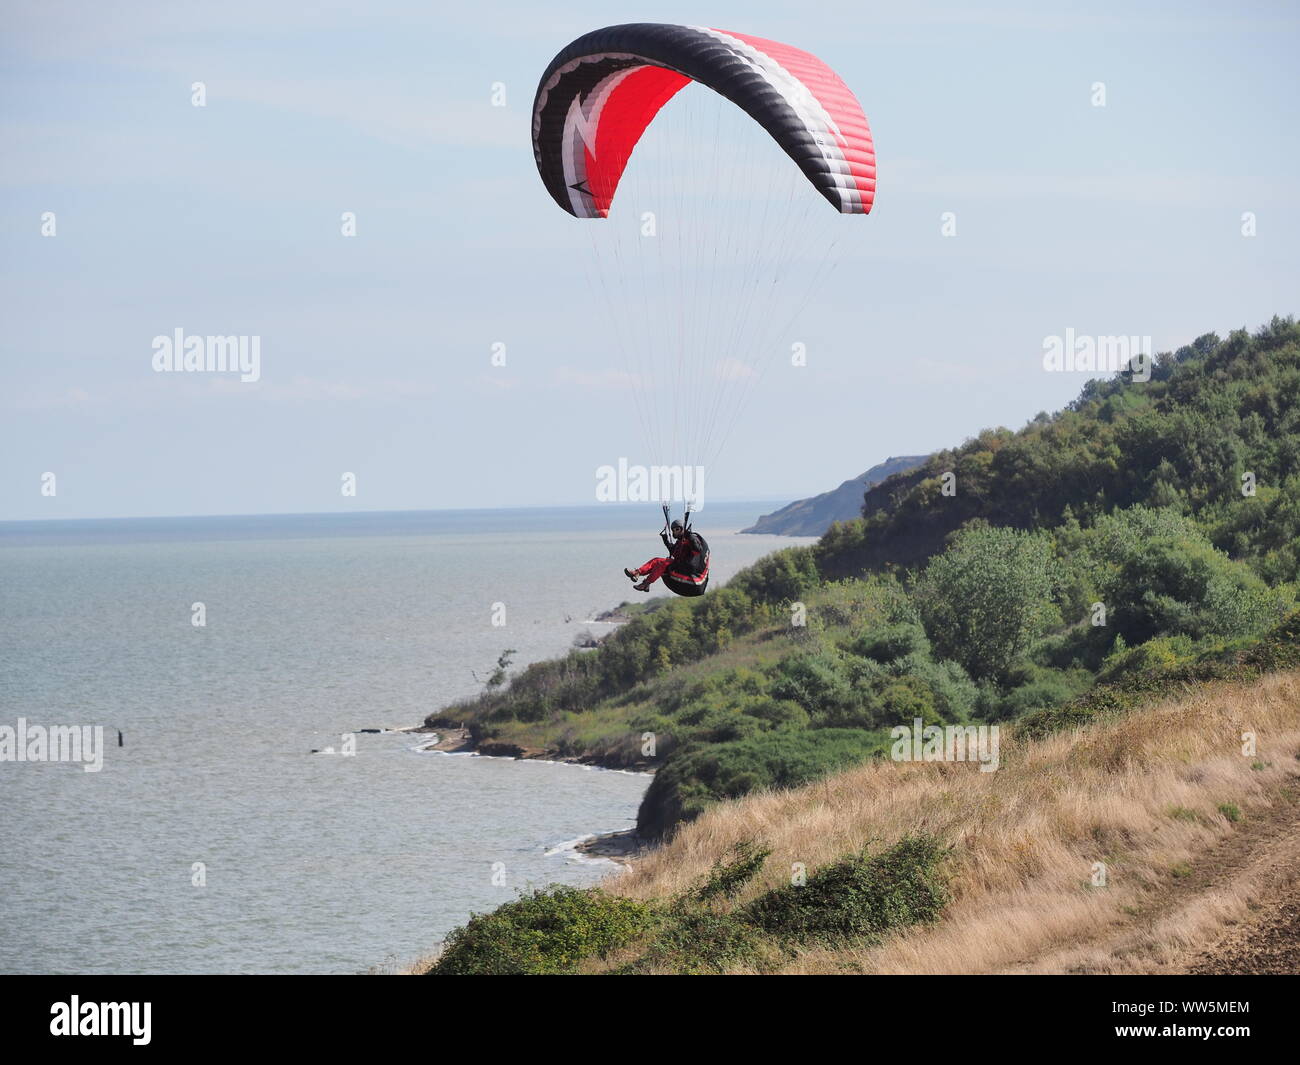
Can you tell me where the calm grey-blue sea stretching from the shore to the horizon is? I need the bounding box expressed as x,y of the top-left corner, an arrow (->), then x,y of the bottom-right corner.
0,503 -> 801,973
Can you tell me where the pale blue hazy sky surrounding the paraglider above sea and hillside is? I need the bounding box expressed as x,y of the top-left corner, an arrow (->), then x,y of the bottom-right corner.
0,0 -> 1300,519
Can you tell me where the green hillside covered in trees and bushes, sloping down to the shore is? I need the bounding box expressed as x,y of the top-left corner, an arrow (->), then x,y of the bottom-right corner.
429,319 -> 1300,839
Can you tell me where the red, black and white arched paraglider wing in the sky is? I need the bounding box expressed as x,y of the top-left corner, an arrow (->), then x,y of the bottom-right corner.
533,22 -> 876,218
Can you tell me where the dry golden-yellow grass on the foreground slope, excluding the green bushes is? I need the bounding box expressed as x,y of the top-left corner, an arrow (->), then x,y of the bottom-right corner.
605,672 -> 1300,973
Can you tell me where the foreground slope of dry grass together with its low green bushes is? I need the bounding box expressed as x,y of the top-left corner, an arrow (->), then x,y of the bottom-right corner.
424,671 -> 1300,974
